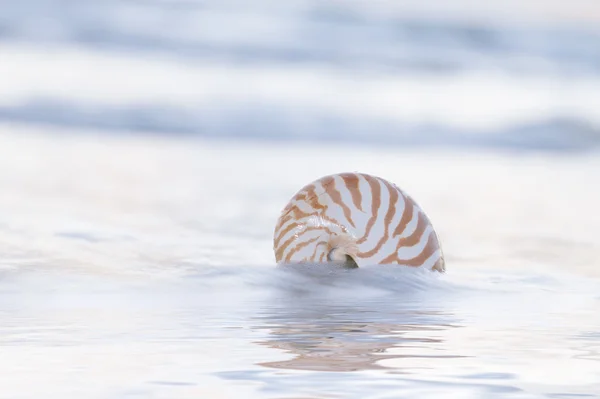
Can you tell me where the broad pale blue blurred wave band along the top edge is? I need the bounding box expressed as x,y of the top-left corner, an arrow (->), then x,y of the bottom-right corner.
0,0 -> 600,75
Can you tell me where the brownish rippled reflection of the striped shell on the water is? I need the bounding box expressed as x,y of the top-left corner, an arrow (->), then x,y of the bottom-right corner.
252,306 -> 454,372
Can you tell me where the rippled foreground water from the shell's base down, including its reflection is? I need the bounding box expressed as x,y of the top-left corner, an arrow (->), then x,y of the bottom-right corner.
2,265 -> 600,398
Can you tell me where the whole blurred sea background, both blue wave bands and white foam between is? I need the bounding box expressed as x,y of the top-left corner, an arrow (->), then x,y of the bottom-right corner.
0,0 -> 600,151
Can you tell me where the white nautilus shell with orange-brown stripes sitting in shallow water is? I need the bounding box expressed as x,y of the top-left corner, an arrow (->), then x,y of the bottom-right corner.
273,173 -> 445,272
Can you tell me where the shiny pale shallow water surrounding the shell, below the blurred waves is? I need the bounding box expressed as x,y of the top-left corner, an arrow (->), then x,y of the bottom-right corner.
0,133 -> 600,398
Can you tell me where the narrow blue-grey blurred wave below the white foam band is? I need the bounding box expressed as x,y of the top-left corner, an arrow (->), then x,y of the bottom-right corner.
0,100 -> 600,152
